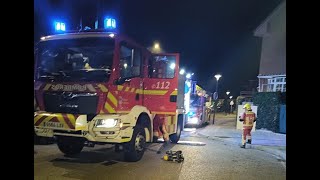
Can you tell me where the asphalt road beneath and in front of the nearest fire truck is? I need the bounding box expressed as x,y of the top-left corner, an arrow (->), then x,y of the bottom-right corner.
34,129 -> 286,180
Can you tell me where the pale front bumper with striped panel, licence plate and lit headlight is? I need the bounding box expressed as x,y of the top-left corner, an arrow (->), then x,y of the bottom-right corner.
34,113 -> 133,143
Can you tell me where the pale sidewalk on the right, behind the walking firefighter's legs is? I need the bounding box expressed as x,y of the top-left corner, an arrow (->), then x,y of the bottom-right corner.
197,113 -> 286,161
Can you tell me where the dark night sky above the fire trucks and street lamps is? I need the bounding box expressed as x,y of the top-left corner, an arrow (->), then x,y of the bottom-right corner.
34,0 -> 282,96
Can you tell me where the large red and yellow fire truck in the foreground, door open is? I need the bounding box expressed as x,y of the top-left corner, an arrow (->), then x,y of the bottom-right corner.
34,19 -> 184,161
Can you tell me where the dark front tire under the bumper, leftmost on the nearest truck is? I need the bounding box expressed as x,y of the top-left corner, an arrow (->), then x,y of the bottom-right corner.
57,136 -> 85,155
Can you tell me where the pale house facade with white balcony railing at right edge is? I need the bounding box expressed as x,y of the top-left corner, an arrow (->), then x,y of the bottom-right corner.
254,1 -> 286,92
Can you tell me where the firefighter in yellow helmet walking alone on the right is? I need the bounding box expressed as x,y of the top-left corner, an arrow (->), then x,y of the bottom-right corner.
240,103 -> 257,148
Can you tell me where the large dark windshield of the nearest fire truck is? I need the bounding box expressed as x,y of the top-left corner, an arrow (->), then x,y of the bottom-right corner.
36,37 -> 115,82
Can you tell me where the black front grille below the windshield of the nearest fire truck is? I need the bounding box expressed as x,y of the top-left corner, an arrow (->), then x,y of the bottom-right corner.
44,92 -> 98,114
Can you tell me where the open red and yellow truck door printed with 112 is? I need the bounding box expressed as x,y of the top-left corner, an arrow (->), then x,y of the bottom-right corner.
143,53 -> 179,115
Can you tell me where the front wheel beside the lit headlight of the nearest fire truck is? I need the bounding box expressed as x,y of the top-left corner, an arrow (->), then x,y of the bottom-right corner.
124,125 -> 146,162
